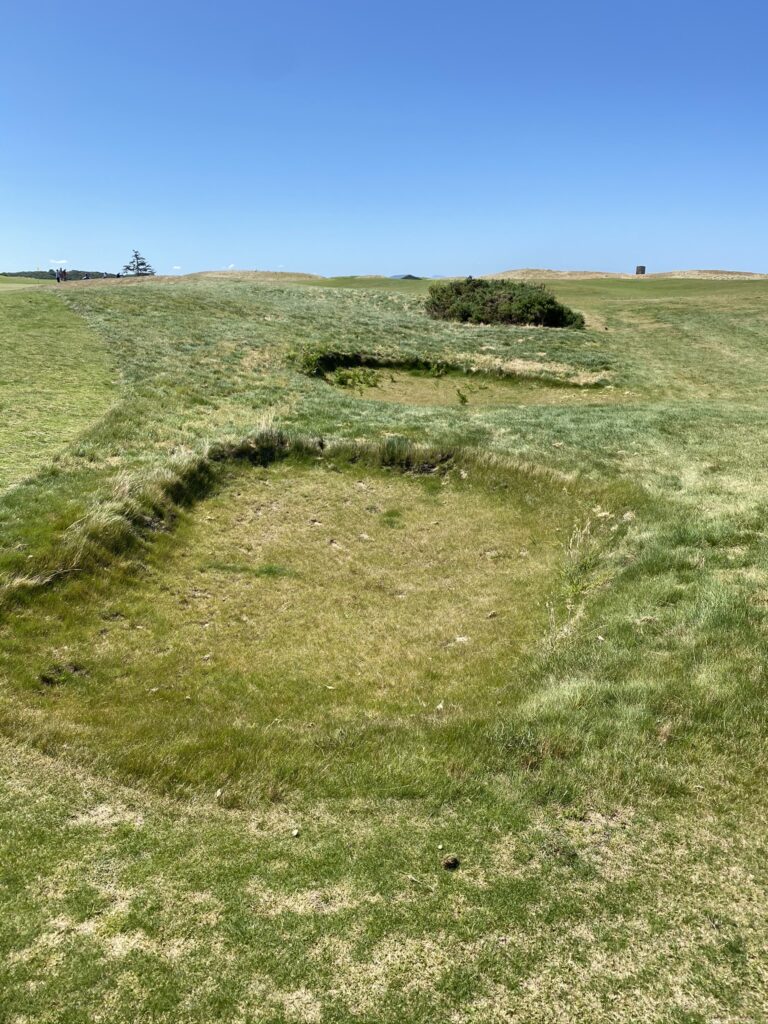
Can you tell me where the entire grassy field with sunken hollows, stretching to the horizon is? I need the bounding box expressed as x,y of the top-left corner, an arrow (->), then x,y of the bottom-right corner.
0,275 -> 768,1024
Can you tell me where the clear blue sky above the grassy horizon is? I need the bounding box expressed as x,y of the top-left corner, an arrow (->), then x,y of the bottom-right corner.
0,0 -> 768,274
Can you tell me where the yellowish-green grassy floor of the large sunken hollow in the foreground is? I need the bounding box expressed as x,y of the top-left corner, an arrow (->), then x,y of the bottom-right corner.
0,460 -> 589,806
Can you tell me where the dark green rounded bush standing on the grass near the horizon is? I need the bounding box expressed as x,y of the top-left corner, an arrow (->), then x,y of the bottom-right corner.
426,278 -> 584,328
